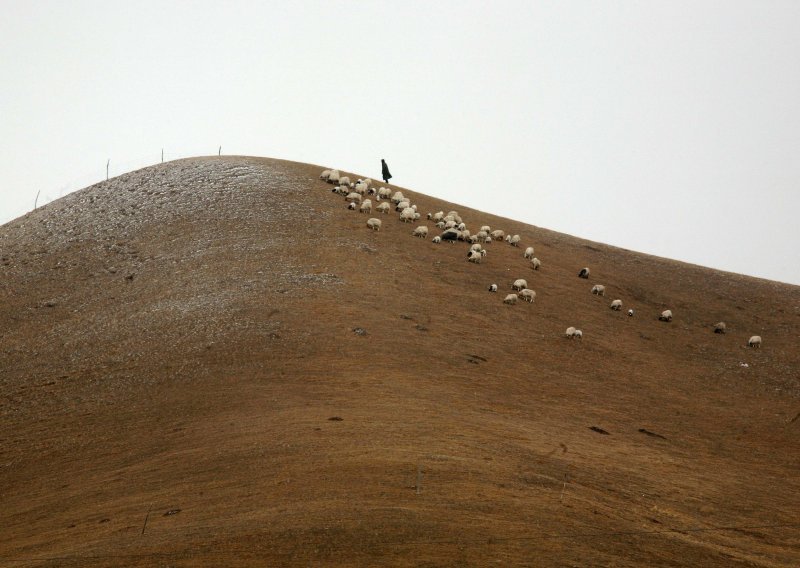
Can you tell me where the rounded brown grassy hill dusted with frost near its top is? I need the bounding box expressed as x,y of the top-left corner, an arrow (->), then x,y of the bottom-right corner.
0,157 -> 800,566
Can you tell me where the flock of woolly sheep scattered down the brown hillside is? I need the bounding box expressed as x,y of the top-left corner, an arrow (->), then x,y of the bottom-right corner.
319,166 -> 761,348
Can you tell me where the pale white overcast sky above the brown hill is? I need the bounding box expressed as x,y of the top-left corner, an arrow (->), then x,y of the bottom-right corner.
0,0 -> 800,284
